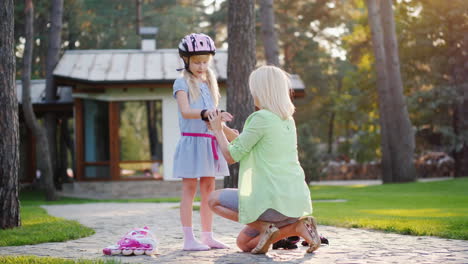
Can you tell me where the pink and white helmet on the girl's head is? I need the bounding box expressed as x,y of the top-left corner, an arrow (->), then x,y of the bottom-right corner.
179,33 -> 216,57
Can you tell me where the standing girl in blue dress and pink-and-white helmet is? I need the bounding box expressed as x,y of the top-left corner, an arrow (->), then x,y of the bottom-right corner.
173,34 -> 236,250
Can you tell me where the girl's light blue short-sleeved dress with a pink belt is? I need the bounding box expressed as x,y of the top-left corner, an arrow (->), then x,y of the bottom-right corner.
173,77 -> 229,178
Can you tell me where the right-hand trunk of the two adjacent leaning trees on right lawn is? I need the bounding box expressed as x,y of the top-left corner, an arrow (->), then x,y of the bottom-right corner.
381,0 -> 416,182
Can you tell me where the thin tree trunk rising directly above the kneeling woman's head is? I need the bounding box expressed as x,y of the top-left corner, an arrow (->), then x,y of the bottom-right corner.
260,0 -> 280,67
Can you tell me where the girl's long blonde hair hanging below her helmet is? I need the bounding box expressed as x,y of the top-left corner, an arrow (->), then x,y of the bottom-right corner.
182,55 -> 221,107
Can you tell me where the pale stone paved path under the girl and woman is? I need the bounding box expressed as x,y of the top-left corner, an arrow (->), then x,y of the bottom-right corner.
0,203 -> 468,264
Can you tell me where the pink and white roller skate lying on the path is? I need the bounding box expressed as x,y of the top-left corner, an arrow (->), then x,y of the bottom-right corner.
102,226 -> 157,256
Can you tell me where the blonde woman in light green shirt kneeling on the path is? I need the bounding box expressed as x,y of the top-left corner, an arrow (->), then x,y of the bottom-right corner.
208,66 -> 320,254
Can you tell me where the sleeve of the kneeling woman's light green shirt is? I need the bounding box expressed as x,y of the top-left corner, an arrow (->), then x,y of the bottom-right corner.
228,112 -> 268,162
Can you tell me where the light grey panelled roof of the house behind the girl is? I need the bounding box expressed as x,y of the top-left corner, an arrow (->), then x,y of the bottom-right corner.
54,49 -> 305,91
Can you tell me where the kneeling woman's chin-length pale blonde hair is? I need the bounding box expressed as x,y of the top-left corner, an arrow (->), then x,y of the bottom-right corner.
249,66 -> 295,120
